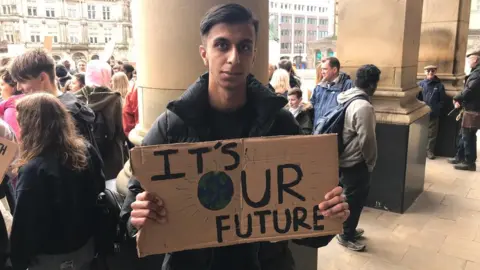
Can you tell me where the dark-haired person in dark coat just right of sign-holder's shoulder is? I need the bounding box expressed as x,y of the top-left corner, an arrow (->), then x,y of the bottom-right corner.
288,88 -> 313,135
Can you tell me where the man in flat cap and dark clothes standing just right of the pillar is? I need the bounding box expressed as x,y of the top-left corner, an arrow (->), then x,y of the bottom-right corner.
417,65 -> 445,159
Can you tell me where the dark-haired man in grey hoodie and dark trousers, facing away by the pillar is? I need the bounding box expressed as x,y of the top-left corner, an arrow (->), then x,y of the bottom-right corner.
337,65 -> 380,251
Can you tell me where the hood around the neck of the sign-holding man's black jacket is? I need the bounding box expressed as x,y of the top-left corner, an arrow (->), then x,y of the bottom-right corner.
167,73 -> 287,132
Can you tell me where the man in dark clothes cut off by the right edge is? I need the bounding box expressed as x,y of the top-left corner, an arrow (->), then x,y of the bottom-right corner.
448,51 -> 480,171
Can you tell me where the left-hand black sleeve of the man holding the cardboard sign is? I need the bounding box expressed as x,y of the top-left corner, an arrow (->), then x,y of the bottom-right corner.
120,113 -> 168,237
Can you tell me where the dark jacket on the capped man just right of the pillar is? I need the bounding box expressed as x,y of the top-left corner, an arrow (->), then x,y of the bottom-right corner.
417,76 -> 445,118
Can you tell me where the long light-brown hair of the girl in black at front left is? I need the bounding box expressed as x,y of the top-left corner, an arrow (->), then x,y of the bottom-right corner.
15,93 -> 88,172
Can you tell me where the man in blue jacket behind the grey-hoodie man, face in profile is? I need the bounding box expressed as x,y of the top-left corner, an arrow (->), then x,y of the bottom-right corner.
310,57 -> 353,133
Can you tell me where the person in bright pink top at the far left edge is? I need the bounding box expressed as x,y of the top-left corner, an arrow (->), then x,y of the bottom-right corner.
0,68 -> 23,140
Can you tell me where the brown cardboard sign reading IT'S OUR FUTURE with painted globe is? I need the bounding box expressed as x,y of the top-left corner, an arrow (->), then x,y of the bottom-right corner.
131,135 -> 342,257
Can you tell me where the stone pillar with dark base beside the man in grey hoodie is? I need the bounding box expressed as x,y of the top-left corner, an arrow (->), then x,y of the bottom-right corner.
337,0 -> 430,213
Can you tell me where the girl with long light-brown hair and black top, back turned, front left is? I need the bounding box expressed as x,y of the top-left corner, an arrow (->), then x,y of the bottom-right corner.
10,93 -> 105,270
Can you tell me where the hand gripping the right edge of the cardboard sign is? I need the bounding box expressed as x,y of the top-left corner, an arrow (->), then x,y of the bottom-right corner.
318,187 -> 350,222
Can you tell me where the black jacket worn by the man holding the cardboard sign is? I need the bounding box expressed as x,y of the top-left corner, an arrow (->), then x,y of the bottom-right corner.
121,74 -> 333,270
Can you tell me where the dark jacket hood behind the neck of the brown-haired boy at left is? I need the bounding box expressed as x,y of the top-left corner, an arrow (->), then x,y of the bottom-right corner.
74,86 -> 121,112
